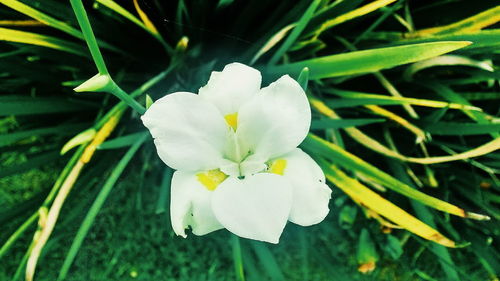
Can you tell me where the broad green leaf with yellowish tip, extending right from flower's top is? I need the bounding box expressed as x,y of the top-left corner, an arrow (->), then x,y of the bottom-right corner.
266,41 -> 471,79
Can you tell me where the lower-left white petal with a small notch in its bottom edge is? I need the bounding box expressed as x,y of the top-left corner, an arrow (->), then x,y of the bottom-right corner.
170,171 -> 224,238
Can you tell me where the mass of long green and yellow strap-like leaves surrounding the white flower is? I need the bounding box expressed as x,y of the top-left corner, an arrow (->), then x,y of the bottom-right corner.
0,0 -> 500,280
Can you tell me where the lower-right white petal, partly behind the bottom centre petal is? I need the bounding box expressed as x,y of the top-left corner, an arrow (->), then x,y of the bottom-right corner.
279,148 -> 332,226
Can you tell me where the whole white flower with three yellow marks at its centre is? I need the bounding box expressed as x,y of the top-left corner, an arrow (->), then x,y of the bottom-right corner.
142,63 -> 331,243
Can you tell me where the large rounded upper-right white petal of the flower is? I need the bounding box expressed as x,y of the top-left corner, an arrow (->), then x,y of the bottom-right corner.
236,75 -> 311,159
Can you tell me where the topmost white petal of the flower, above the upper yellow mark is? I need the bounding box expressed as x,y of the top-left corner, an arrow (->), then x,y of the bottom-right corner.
199,63 -> 262,116
